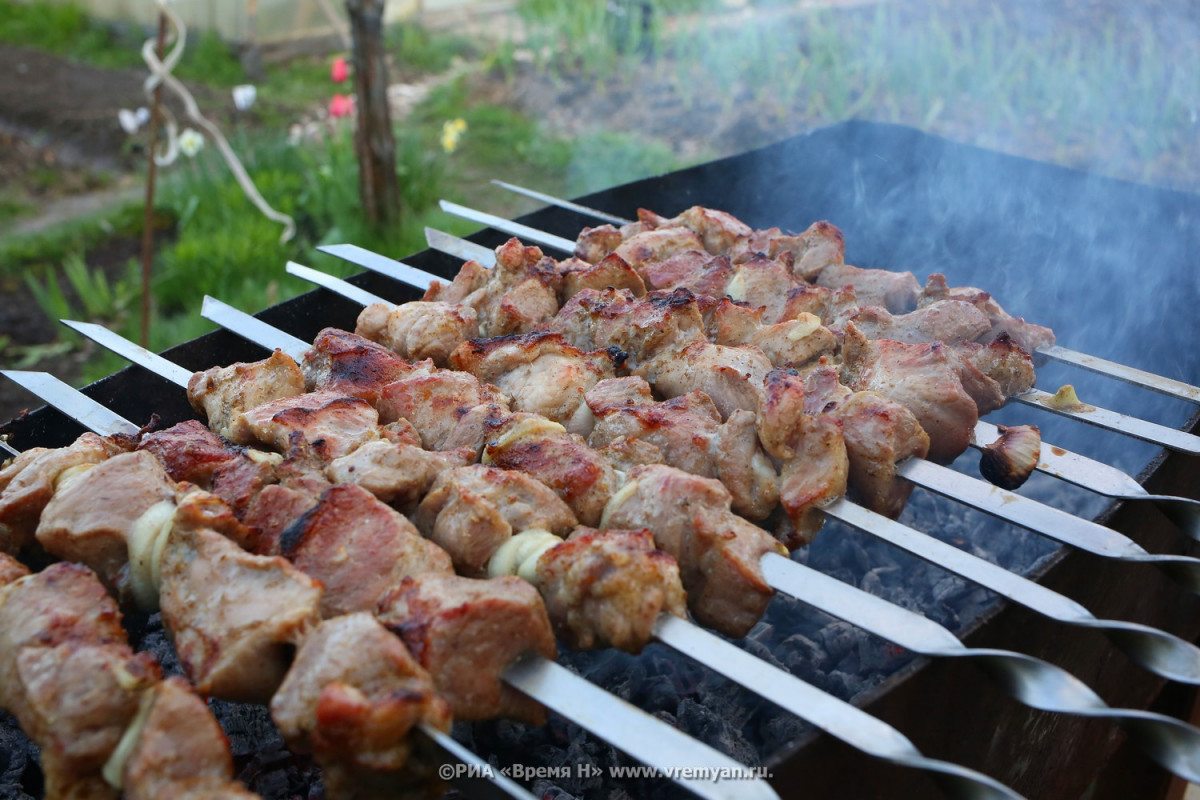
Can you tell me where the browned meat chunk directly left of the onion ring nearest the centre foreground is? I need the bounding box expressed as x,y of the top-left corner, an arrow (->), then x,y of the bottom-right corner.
416,465 -> 576,578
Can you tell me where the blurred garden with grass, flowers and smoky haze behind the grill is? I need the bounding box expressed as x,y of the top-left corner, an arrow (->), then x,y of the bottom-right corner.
0,0 -> 1200,419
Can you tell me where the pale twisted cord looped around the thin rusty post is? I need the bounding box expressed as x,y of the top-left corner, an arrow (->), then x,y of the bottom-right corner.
142,0 -> 296,243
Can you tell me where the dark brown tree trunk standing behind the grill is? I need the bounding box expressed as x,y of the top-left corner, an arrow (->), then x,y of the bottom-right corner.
346,0 -> 400,225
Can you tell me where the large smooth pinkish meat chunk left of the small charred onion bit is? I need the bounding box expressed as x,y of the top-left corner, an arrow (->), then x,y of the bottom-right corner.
841,323 -> 979,464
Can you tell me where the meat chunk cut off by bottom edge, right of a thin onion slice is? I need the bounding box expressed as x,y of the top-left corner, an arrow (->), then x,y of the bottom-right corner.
122,678 -> 258,800
